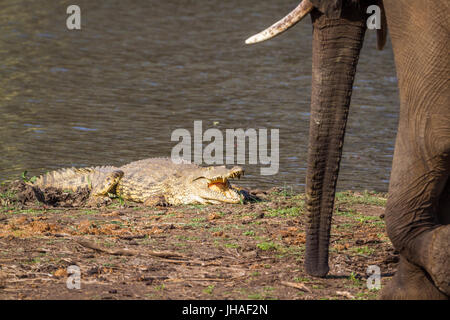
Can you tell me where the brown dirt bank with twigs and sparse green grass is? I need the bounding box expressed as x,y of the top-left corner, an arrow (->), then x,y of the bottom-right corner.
0,182 -> 398,300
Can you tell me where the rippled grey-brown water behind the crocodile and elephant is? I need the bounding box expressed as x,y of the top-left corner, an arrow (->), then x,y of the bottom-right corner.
0,0 -> 399,191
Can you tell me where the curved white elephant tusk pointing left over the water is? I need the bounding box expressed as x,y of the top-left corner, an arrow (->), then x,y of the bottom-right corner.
245,0 -> 314,44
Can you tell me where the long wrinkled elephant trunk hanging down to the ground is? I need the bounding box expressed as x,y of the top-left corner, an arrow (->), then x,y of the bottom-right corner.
305,10 -> 366,277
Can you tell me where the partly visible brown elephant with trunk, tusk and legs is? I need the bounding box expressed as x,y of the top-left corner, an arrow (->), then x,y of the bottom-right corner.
248,0 -> 450,299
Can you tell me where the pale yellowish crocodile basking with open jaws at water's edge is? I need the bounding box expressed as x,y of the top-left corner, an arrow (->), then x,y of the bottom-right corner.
29,158 -> 244,206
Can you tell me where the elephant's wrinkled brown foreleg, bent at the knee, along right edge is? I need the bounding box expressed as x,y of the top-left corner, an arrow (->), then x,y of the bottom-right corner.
383,0 -> 450,296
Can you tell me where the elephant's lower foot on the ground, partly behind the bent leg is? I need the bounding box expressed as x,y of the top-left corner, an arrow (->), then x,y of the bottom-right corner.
380,256 -> 448,300
